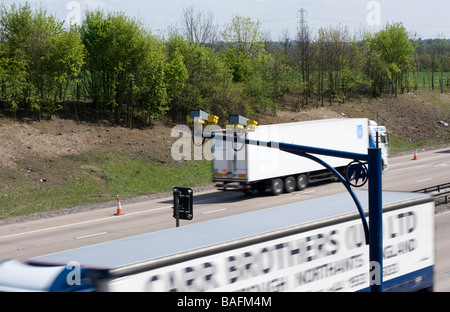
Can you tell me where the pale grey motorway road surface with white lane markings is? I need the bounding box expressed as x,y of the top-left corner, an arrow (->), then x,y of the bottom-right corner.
0,147 -> 450,291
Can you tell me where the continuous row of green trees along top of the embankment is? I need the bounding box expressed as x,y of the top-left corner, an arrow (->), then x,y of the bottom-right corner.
0,3 -> 450,127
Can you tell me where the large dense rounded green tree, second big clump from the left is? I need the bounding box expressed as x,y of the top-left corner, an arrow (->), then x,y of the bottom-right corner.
81,10 -> 168,128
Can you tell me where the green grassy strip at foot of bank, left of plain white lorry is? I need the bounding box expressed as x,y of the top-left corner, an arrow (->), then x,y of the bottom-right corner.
0,153 -> 211,219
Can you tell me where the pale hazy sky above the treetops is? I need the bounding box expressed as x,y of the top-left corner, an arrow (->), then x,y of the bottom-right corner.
6,0 -> 450,40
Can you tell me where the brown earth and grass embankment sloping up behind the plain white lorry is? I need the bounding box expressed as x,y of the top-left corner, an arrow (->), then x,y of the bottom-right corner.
0,90 -> 450,222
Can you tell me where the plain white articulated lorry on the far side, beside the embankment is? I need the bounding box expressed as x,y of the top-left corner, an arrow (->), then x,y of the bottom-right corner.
212,118 -> 388,195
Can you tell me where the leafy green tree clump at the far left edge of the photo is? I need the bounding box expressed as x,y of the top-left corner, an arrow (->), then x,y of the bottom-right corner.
0,3 -> 83,119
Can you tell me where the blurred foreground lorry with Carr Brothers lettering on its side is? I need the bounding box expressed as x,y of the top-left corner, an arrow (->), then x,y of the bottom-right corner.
0,191 -> 435,292
